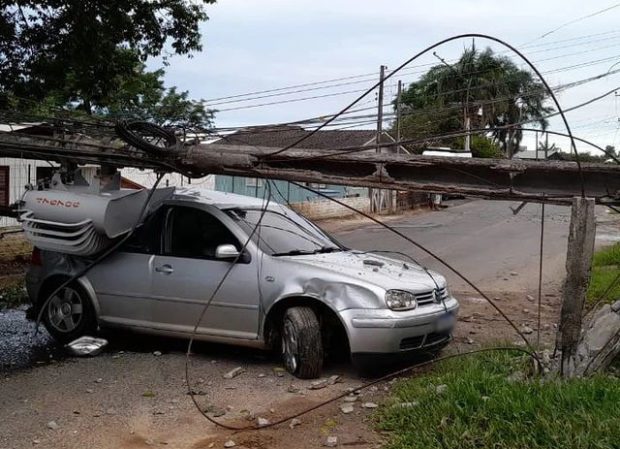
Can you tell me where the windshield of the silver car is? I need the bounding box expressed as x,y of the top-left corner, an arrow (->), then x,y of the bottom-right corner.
226,208 -> 343,256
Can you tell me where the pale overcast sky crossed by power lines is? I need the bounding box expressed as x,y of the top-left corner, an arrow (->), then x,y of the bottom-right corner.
151,0 -> 620,154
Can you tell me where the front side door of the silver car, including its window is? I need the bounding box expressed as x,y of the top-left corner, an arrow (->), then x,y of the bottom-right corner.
150,205 -> 260,339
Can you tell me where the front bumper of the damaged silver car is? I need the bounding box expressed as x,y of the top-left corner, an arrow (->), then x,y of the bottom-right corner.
340,297 -> 459,358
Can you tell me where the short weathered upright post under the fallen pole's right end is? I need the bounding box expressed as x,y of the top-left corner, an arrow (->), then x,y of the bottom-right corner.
558,197 -> 596,377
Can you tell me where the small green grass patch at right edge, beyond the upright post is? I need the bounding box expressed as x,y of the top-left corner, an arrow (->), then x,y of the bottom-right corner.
587,243 -> 620,303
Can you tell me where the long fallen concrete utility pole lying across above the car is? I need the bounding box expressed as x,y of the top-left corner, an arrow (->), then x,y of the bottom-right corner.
0,133 -> 620,204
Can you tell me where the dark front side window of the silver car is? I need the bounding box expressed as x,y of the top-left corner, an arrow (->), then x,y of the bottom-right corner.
164,207 -> 241,259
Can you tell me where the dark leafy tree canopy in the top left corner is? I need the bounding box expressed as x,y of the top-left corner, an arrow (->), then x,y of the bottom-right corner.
0,0 -> 215,114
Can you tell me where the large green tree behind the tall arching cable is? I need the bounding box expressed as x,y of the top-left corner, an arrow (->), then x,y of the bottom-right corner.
400,48 -> 553,157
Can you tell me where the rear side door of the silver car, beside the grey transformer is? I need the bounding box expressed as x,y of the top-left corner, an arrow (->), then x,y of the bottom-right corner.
87,209 -> 166,328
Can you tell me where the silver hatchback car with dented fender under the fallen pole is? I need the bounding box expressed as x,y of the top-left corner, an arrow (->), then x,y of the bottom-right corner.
26,189 -> 459,378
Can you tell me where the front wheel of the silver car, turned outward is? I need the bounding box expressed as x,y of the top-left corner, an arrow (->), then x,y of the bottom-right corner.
280,307 -> 323,379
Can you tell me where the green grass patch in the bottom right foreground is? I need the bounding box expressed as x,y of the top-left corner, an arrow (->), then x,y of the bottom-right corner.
376,352 -> 620,449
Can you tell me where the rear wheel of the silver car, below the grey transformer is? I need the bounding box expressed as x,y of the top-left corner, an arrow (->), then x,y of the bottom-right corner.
39,282 -> 97,344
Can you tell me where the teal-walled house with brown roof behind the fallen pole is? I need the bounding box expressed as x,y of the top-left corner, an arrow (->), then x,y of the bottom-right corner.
215,125 -> 408,214
